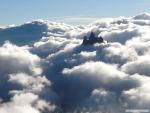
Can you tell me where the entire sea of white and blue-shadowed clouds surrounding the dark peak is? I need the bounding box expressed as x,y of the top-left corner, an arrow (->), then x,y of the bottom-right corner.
0,13 -> 150,113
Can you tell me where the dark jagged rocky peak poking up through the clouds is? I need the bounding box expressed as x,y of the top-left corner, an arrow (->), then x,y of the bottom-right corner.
82,32 -> 104,45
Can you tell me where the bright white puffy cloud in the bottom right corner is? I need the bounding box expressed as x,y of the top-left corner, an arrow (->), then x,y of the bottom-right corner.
122,74 -> 150,109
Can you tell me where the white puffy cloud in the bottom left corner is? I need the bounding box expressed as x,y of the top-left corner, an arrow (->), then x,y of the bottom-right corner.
0,93 -> 55,113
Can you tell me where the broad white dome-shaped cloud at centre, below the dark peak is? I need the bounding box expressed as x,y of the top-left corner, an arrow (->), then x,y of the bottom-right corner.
63,62 -> 126,84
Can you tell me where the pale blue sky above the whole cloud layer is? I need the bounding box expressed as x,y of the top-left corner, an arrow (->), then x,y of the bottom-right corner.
0,0 -> 150,25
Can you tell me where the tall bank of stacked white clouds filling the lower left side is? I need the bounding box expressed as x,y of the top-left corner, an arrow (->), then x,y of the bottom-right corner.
0,42 -> 55,113
